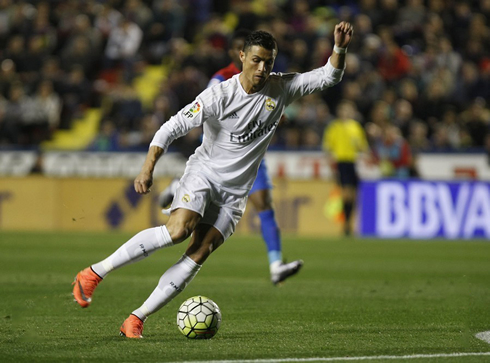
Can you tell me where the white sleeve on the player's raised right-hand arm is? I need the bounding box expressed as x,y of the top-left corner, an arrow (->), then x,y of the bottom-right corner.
285,58 -> 344,105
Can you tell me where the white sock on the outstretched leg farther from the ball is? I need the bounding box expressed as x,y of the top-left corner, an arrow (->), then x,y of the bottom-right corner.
92,226 -> 173,278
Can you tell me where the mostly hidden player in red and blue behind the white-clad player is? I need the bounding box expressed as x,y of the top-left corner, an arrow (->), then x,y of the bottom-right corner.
158,29 -> 303,285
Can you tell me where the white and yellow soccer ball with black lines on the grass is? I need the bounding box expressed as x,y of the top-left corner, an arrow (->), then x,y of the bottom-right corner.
177,295 -> 221,339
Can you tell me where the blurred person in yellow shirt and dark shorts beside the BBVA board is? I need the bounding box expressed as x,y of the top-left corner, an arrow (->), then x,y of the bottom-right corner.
323,100 -> 369,236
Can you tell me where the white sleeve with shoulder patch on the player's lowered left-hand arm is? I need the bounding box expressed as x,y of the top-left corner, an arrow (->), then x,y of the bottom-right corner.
150,96 -> 209,152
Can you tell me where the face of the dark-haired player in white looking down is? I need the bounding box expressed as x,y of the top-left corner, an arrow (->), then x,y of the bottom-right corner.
240,45 -> 276,92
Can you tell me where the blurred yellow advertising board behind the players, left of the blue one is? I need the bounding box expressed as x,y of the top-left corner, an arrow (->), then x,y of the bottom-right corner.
0,176 -> 341,236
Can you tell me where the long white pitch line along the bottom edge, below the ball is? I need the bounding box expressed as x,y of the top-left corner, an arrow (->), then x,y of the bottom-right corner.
168,352 -> 490,363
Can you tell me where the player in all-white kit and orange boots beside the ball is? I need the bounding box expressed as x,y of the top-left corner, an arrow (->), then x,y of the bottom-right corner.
73,22 -> 353,338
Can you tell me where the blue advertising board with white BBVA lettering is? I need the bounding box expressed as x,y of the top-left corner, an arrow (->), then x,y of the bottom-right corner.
358,180 -> 490,239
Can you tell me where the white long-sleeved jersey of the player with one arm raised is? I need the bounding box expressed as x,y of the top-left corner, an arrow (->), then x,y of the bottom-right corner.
150,60 -> 344,196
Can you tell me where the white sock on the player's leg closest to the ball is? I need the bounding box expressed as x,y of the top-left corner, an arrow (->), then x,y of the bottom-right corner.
132,255 -> 201,321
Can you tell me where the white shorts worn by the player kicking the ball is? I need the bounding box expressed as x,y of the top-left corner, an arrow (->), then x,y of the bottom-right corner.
171,172 -> 248,240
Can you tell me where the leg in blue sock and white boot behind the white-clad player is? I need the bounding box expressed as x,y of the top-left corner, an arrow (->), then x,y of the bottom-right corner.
248,161 -> 303,284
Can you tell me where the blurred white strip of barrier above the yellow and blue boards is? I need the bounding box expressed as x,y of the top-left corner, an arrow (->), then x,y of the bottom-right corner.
0,151 -> 490,180
